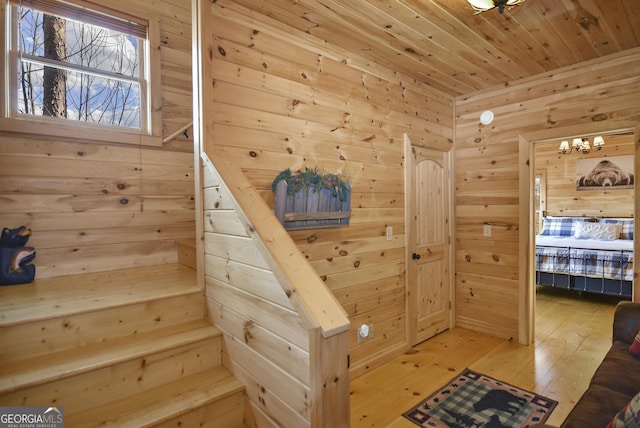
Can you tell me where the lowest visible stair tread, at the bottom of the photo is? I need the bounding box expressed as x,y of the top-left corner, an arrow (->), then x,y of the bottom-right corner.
65,366 -> 244,428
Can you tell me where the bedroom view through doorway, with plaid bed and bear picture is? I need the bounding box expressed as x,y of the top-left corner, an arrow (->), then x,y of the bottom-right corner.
529,129 -> 636,332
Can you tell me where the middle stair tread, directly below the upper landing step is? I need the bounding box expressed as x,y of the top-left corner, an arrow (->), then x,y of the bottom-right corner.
0,319 -> 221,394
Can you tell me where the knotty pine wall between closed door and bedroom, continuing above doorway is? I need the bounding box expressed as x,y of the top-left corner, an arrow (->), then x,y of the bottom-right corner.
455,49 -> 640,340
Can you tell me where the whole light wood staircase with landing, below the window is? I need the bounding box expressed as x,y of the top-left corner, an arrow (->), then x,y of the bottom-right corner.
0,264 -> 247,428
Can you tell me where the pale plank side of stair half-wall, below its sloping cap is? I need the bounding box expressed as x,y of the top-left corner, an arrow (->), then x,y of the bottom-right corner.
203,163 -> 311,427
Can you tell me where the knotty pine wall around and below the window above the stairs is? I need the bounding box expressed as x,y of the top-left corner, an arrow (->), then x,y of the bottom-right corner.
0,0 -> 195,278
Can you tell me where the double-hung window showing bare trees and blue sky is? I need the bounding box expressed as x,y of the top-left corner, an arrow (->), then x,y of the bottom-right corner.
3,0 -> 157,144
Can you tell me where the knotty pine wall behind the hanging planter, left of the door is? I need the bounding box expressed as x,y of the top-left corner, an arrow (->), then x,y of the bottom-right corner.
203,0 -> 453,375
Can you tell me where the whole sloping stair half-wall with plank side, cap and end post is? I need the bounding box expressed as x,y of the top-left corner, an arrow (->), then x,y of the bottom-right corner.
201,154 -> 349,427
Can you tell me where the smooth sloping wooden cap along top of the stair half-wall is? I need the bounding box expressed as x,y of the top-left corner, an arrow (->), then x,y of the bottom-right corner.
200,148 -> 350,338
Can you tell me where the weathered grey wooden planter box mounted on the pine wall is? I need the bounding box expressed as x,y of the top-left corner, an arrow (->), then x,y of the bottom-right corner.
275,180 -> 351,230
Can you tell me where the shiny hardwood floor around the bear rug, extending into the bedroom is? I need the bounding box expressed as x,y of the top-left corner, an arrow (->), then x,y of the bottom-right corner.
351,287 -> 617,428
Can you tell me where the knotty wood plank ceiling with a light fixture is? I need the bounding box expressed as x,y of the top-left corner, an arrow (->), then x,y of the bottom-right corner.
229,0 -> 640,96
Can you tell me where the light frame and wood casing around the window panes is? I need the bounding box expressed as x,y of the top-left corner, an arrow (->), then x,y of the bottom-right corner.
0,0 -> 162,146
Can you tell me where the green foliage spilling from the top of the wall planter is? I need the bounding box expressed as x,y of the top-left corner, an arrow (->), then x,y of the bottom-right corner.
271,168 -> 351,202
